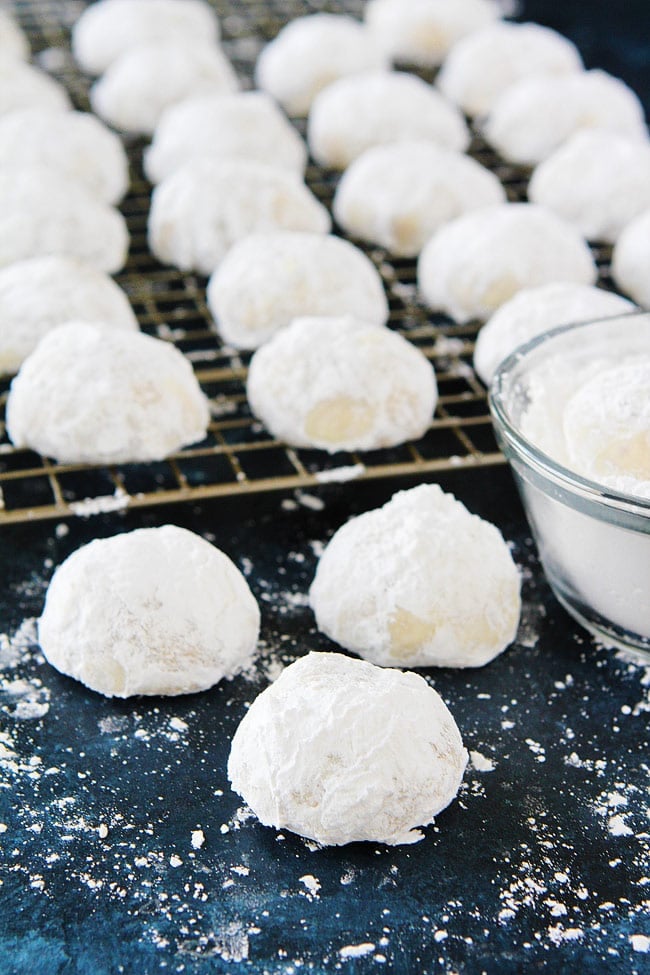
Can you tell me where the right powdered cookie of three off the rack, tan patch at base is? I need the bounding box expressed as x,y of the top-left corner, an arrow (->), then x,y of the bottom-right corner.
309,484 -> 521,667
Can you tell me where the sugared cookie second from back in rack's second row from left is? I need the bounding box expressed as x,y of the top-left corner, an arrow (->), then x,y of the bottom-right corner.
90,41 -> 238,135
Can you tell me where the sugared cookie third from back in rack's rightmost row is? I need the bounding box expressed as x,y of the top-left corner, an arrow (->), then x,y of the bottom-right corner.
483,71 -> 648,166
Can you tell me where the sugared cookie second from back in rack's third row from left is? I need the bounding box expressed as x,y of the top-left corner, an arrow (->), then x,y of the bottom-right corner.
308,71 -> 469,169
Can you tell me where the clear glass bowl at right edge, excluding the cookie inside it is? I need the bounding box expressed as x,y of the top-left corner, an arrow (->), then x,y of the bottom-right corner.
489,312 -> 650,661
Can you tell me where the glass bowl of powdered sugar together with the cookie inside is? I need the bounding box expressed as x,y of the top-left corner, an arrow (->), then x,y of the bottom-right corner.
490,312 -> 650,659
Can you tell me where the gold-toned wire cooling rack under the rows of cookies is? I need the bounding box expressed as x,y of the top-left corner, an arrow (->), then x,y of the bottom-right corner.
0,0 -> 610,524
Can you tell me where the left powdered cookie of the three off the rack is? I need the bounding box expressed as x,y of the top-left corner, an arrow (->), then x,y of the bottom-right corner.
38,525 -> 260,697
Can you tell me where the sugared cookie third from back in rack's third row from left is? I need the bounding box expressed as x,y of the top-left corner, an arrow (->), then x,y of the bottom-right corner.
333,141 -> 506,257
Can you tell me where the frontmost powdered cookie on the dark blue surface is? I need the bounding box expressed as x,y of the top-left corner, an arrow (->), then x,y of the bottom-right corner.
228,653 -> 467,846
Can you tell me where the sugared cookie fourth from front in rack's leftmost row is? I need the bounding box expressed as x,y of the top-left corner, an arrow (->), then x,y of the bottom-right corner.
0,108 -> 129,203
